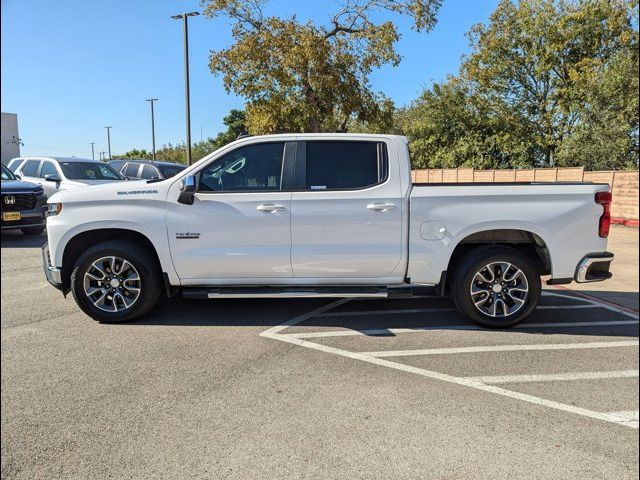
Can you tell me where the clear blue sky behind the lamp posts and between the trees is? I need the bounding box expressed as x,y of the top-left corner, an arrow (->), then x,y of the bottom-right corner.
1,0 -> 497,158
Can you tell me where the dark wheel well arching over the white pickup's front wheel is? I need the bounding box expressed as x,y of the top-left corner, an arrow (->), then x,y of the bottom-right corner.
62,228 -> 161,292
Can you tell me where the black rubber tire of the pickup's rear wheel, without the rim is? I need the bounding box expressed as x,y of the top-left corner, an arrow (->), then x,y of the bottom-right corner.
451,246 -> 542,328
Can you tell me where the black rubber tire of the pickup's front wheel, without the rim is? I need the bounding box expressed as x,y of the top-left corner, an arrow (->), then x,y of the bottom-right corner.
71,240 -> 162,323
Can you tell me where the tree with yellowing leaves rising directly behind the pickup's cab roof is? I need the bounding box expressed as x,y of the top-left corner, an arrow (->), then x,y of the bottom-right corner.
203,0 -> 441,133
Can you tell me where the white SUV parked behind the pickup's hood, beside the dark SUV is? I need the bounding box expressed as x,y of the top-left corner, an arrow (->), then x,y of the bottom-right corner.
9,157 -> 125,197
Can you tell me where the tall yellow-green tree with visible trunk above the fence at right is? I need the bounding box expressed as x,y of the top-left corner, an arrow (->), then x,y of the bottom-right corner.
462,0 -> 638,166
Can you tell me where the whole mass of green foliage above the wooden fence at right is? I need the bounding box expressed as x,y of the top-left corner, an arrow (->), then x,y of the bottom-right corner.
397,0 -> 638,169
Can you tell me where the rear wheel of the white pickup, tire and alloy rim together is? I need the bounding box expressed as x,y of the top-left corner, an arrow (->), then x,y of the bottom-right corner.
451,247 -> 541,328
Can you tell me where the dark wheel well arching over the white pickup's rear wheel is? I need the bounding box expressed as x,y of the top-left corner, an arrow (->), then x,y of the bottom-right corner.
440,229 -> 551,293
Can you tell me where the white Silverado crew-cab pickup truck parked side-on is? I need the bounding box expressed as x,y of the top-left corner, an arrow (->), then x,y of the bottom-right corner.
43,134 -> 613,327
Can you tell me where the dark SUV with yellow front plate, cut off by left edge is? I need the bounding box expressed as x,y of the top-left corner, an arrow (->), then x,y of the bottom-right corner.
2,164 -> 47,235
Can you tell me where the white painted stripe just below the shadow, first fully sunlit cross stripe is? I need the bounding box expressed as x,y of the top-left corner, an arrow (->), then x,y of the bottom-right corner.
362,340 -> 638,358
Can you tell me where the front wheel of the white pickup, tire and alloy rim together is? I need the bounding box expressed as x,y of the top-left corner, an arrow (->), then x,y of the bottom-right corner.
71,240 -> 162,323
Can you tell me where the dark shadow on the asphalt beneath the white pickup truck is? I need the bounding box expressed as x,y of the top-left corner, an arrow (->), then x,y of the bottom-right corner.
129,293 -> 638,337
